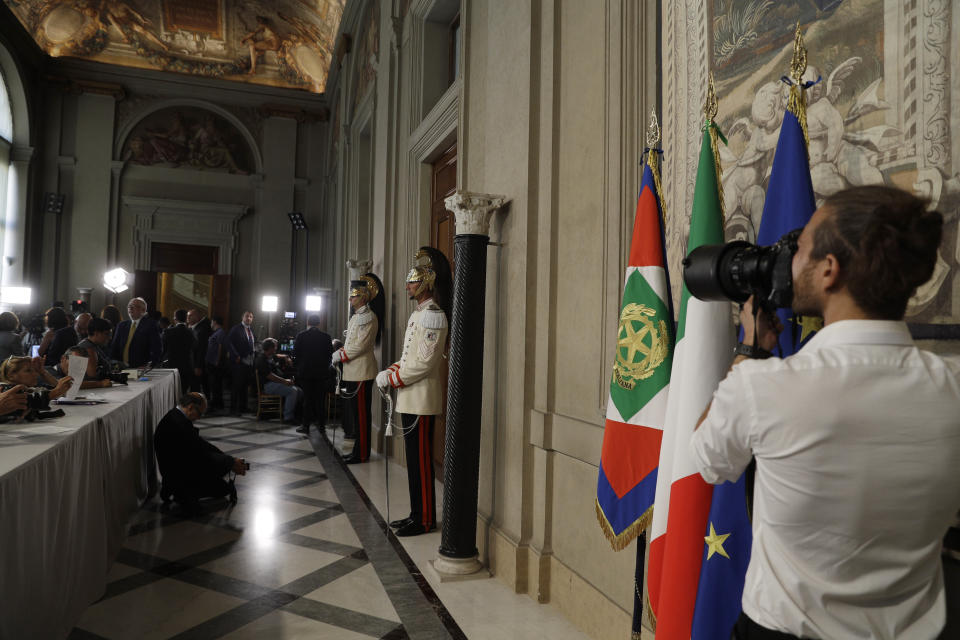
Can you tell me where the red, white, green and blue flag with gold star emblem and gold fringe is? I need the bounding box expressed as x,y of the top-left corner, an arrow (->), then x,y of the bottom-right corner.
596,151 -> 673,550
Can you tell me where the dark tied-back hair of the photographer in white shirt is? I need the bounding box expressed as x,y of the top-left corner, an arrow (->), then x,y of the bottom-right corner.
810,186 -> 943,320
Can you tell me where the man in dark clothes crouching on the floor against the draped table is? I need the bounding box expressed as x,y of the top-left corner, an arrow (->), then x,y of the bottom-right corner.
153,392 -> 247,512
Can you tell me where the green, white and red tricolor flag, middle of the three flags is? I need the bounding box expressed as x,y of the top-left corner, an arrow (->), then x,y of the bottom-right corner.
647,122 -> 735,640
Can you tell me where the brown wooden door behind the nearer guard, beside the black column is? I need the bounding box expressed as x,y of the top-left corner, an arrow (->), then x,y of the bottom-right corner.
430,144 -> 457,470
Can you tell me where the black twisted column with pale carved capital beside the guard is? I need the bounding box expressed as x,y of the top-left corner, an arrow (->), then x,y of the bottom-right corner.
434,192 -> 503,575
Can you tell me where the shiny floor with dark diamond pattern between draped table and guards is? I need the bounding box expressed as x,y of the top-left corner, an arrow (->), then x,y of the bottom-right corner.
70,417 -> 467,640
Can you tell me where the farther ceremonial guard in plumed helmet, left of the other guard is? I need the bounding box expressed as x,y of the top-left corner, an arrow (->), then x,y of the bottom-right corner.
331,273 -> 384,464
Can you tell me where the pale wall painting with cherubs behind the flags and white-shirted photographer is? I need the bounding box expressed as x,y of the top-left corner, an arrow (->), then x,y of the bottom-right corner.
709,0 -> 960,323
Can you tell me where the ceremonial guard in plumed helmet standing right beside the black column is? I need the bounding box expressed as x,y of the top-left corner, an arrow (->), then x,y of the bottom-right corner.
377,247 -> 452,536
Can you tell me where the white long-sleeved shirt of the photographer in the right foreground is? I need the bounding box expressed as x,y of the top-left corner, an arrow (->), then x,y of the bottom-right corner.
690,320 -> 960,640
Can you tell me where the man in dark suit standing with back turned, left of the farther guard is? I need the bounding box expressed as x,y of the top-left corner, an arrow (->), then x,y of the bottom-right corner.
293,314 -> 333,433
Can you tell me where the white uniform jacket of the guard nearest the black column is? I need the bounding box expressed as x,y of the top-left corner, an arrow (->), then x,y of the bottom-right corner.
389,298 -> 447,416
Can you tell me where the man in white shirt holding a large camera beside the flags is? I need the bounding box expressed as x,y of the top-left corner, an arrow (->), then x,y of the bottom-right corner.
690,186 -> 960,639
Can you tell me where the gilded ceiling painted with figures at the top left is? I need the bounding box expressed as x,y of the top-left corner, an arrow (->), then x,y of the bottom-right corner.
4,0 -> 345,93
